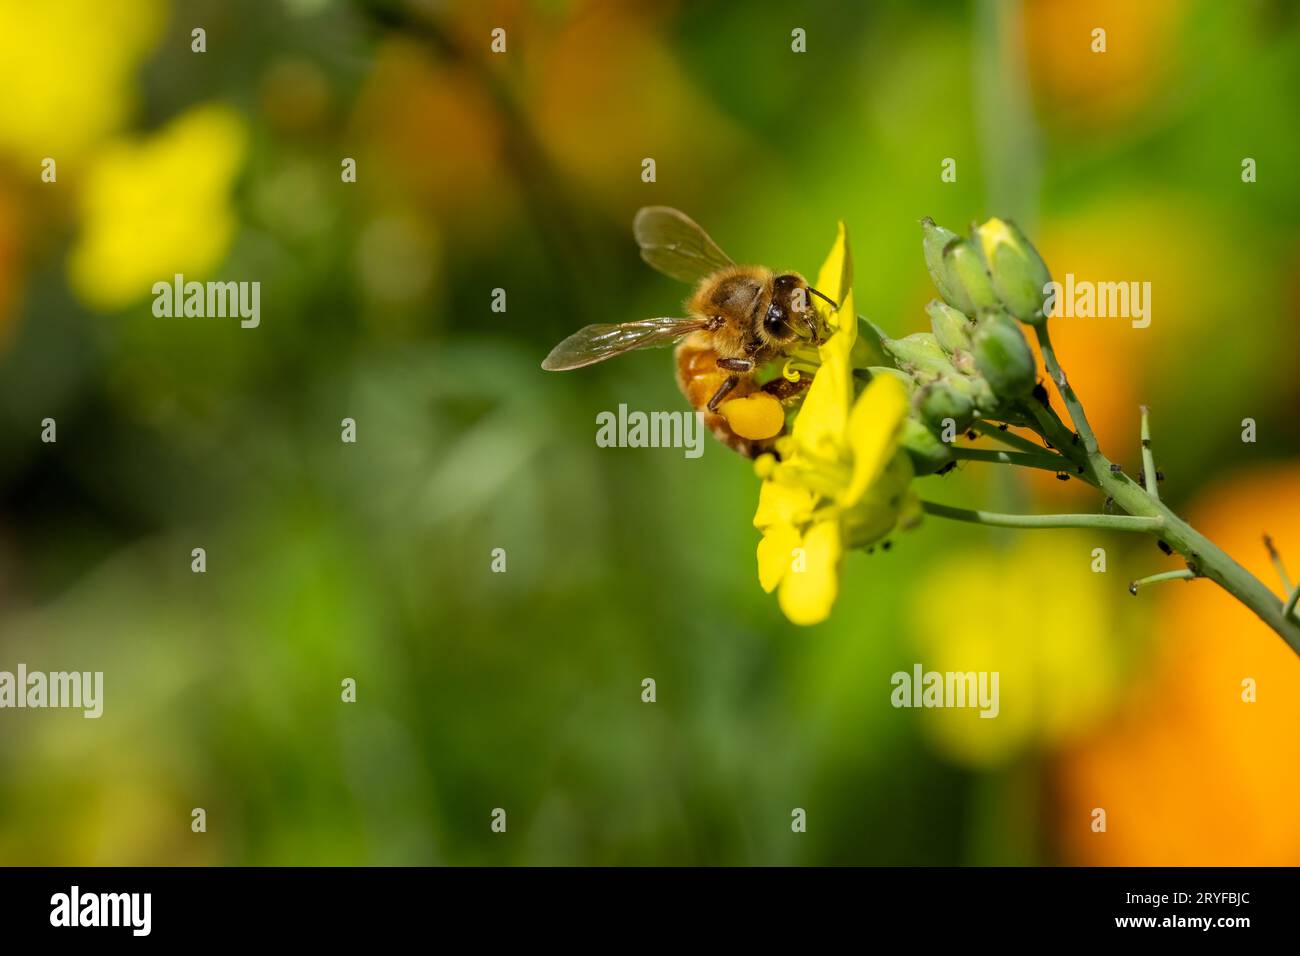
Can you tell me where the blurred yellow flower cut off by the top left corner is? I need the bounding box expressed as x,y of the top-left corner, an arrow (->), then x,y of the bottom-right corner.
0,0 -> 166,165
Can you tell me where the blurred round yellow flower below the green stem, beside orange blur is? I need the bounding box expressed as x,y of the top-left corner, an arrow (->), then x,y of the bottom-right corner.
909,531 -> 1127,769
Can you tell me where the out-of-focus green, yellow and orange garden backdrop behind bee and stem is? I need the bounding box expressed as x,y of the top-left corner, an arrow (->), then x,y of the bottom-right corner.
0,0 -> 1300,865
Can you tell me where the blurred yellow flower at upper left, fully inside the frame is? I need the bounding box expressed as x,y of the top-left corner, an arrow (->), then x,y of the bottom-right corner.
68,104 -> 247,308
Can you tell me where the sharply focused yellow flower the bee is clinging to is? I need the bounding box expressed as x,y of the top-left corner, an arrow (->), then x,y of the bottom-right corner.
754,222 -> 919,624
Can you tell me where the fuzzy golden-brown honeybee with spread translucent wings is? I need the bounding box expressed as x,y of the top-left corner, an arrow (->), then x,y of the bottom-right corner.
542,206 -> 839,458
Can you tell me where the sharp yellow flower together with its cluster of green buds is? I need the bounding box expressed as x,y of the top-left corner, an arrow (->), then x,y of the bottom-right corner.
754,219 -> 1049,624
